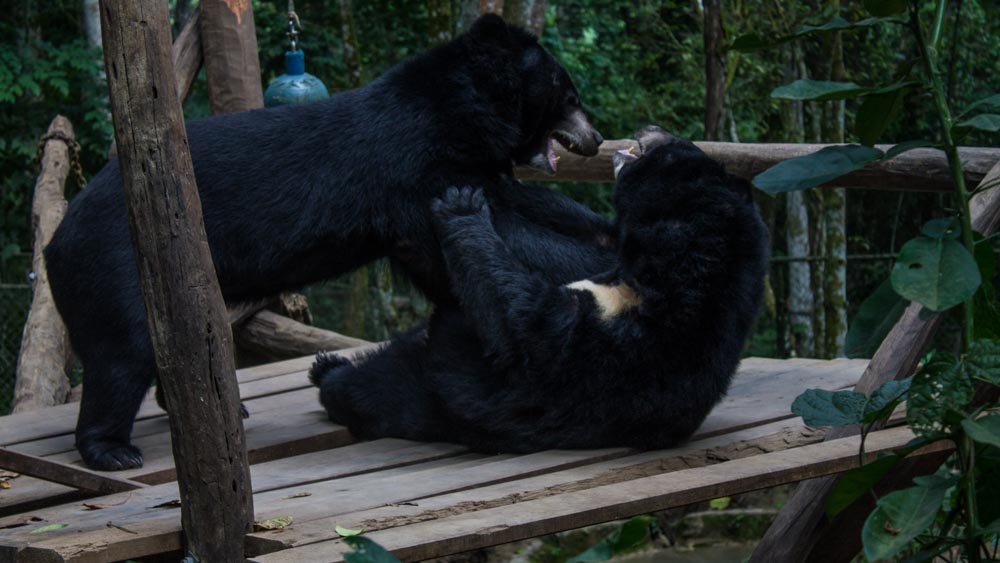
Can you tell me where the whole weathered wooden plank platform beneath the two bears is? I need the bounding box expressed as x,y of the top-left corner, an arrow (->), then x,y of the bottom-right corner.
0,349 -> 911,562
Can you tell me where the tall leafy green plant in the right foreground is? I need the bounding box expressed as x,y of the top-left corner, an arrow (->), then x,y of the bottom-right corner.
734,0 -> 1000,561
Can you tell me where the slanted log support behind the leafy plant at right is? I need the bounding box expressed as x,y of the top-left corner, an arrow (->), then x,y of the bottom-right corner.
751,159 -> 1000,563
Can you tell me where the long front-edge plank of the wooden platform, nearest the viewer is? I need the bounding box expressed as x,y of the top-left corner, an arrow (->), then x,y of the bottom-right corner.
251,428 -> 946,563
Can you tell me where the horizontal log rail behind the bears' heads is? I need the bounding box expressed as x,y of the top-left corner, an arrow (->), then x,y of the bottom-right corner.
515,139 -> 1000,193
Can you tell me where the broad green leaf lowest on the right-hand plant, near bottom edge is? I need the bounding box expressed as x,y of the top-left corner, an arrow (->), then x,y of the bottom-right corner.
861,487 -> 945,561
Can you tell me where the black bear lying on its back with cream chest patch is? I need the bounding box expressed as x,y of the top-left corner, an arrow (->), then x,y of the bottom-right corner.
310,127 -> 768,452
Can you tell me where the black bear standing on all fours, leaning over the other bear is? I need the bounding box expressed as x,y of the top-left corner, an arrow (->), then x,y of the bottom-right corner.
45,16 -> 613,470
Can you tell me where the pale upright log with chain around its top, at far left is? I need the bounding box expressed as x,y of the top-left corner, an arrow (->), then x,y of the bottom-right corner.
12,115 -> 73,413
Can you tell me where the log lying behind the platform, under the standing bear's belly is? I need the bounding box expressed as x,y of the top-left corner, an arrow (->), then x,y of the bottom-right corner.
235,311 -> 369,359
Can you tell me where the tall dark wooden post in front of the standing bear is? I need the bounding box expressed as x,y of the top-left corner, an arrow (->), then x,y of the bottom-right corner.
101,0 -> 253,561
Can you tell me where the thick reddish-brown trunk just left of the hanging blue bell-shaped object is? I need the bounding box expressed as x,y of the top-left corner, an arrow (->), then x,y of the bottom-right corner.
199,0 -> 264,114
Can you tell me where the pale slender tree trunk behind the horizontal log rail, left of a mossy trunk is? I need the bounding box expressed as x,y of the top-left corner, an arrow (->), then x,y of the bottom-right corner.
781,45 -> 815,356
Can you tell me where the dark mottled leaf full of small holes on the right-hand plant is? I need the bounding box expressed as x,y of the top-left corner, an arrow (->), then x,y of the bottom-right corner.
906,354 -> 973,438
